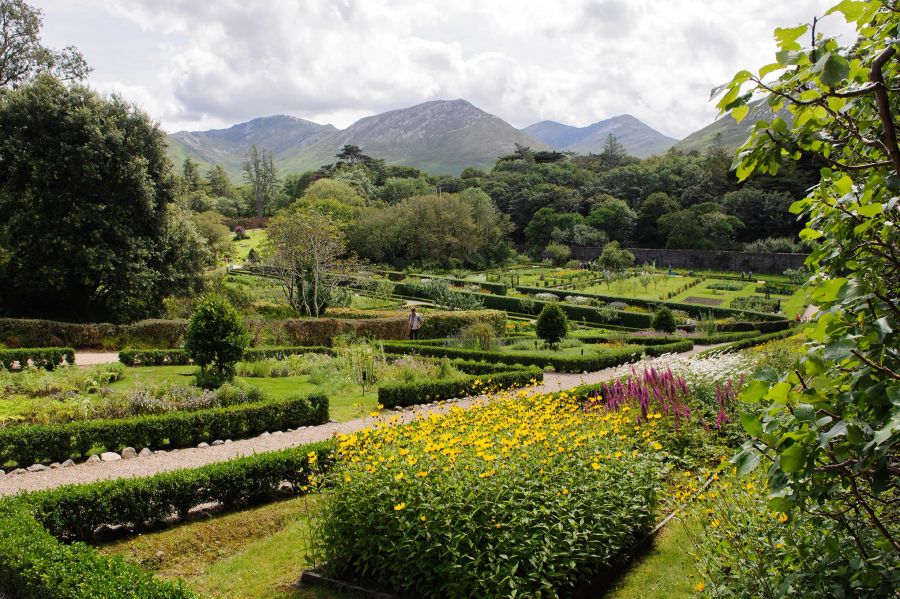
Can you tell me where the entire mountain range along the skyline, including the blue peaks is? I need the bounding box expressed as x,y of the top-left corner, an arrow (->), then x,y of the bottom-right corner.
168,100 -> 752,180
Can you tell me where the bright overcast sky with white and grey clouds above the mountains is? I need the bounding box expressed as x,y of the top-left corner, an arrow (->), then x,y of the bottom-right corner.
30,0 -> 849,138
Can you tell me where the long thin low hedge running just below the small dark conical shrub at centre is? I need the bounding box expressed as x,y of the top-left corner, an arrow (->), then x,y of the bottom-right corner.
383,340 -> 694,372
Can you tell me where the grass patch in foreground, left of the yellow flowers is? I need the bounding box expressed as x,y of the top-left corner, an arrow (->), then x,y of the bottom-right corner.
100,496 -> 346,599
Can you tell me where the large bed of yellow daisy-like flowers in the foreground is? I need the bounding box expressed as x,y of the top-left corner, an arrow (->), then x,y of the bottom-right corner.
316,393 -> 664,597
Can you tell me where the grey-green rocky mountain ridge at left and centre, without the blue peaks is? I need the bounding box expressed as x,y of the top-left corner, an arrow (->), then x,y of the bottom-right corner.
169,100 -> 551,178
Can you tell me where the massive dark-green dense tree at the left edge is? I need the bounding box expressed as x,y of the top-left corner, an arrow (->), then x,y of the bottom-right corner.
0,74 -> 205,321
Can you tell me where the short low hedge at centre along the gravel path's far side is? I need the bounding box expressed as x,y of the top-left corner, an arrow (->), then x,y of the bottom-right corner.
378,367 -> 544,408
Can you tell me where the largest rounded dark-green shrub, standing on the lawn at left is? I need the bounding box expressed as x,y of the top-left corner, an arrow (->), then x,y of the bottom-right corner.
184,295 -> 249,389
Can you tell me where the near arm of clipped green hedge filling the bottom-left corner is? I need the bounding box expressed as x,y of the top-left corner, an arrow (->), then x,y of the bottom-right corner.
0,499 -> 197,599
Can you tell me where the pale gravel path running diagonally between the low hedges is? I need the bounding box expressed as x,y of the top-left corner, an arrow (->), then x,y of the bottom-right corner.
0,345 -> 715,496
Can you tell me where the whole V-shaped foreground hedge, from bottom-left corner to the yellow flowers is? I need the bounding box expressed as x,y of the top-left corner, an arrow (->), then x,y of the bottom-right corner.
0,442 -> 333,599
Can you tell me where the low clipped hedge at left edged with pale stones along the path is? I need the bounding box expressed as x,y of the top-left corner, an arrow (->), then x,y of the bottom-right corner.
0,393 -> 328,466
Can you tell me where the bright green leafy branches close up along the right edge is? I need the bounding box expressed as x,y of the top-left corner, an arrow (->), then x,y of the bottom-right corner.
717,0 -> 900,587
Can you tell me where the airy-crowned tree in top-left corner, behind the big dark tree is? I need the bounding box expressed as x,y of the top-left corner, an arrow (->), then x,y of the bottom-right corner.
0,0 -> 91,88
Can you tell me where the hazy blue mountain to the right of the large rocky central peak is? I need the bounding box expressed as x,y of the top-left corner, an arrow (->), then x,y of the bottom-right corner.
522,114 -> 678,158
